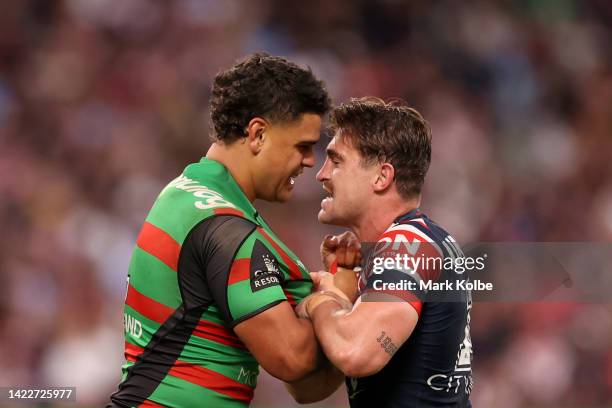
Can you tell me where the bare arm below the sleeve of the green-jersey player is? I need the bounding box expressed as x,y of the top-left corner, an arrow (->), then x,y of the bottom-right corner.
234,302 -> 323,382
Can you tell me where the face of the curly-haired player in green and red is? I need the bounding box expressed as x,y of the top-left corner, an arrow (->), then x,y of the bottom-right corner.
255,113 -> 321,202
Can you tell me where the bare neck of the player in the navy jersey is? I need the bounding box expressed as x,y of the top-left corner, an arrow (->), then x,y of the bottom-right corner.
350,197 -> 420,242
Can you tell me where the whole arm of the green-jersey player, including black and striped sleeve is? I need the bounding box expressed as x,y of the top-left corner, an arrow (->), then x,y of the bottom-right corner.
191,216 -> 322,381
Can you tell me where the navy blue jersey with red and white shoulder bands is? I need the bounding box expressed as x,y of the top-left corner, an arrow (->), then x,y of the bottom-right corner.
346,210 -> 473,408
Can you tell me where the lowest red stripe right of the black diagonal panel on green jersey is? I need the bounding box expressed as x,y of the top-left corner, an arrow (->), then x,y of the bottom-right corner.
168,361 -> 253,403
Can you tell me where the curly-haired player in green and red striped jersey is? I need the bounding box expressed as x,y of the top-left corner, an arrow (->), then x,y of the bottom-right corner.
109,54 -> 352,407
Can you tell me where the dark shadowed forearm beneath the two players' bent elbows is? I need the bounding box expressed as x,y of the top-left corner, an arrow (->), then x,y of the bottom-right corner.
285,361 -> 344,404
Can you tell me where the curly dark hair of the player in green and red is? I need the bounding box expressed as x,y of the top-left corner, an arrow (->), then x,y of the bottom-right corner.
210,53 -> 331,143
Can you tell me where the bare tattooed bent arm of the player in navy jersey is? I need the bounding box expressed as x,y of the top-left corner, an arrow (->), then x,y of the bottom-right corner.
311,294 -> 418,377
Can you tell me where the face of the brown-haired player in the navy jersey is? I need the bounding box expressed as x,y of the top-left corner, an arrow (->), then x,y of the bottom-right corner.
317,133 -> 376,227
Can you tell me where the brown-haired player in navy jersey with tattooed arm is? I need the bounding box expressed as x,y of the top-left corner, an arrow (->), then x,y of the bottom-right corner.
299,98 -> 472,408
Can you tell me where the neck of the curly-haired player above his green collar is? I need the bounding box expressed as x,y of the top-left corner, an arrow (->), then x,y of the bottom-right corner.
206,140 -> 255,202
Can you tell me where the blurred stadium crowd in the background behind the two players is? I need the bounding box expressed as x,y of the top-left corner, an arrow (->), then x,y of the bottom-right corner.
0,0 -> 612,408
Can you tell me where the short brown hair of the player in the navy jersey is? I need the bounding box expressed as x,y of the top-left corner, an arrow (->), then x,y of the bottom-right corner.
331,97 -> 431,198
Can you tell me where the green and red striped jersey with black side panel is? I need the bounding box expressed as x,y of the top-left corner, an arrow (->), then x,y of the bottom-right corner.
109,158 -> 312,407
